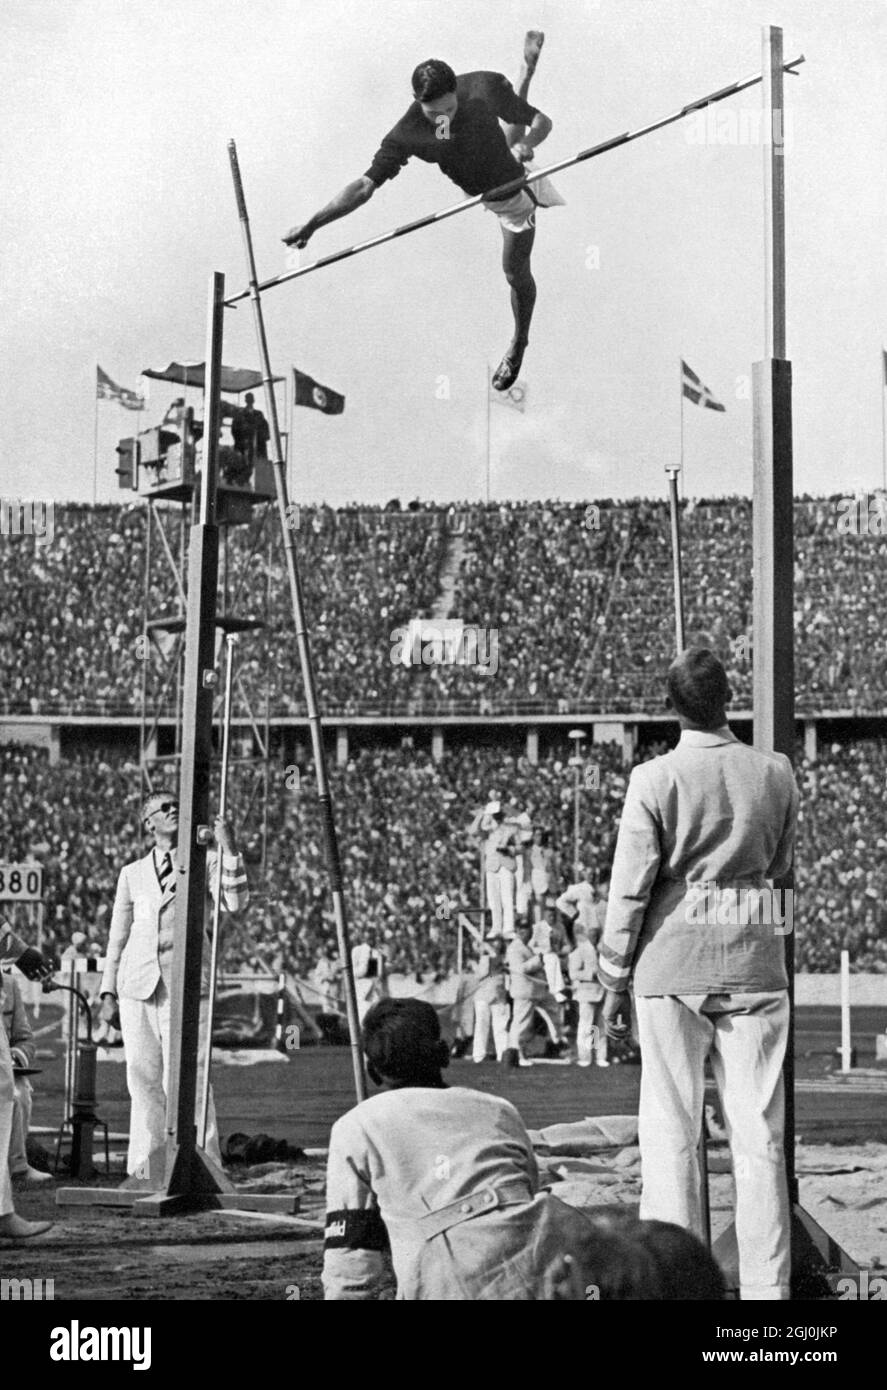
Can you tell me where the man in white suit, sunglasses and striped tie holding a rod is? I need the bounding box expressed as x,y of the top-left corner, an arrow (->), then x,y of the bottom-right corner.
101,791 -> 249,1177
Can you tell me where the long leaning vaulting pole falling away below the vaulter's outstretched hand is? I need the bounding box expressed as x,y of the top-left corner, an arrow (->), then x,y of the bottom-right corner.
228,140 -> 367,1101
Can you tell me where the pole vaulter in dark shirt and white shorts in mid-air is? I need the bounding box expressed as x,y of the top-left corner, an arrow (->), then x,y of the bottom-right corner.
284,29 -> 563,391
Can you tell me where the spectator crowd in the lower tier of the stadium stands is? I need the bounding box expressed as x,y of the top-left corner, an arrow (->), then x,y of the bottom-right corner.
0,738 -> 887,981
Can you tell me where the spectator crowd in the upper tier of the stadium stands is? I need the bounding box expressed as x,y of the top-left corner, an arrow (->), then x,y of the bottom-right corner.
0,498 -> 887,716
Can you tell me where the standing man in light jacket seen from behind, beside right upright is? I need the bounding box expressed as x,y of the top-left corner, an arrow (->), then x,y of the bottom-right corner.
599,648 -> 798,1300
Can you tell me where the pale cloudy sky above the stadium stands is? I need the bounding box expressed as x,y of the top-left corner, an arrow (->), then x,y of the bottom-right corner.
0,0 -> 887,505
